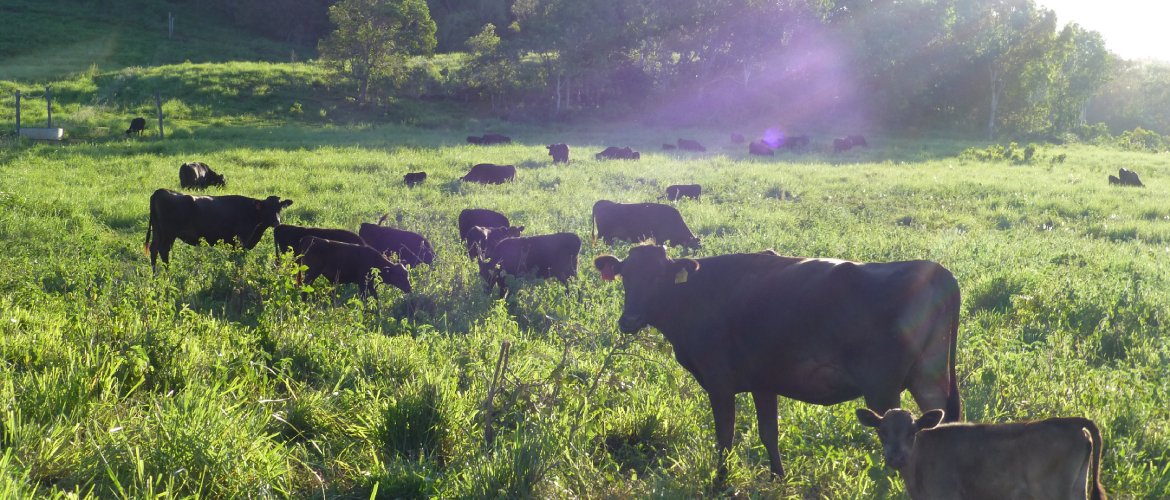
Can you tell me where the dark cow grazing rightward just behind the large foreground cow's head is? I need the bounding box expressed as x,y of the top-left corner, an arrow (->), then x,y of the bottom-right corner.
593,200 -> 698,247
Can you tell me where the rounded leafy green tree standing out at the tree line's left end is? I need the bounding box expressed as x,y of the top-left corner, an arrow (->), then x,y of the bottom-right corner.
318,0 -> 435,104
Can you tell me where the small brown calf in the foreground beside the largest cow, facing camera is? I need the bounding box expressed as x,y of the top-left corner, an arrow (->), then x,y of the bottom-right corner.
856,409 -> 1106,500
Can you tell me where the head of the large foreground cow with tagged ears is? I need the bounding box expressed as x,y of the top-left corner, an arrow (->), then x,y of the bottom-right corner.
593,245 -> 698,334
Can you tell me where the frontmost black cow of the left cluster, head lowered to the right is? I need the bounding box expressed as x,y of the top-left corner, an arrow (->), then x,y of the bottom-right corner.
296,235 -> 411,300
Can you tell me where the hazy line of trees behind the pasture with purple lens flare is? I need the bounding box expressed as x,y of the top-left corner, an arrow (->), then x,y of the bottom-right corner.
177,0 -> 1170,137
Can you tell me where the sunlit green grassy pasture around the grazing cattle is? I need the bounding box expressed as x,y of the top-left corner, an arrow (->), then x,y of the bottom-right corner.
0,119 -> 1170,499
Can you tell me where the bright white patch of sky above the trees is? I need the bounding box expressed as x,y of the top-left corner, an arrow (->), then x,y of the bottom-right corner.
1035,0 -> 1170,62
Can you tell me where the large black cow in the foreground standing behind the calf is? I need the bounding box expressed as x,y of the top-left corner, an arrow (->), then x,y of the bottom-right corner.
594,245 -> 962,478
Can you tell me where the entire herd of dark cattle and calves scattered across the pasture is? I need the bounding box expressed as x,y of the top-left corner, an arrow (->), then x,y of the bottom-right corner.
136,133 -> 1104,499
